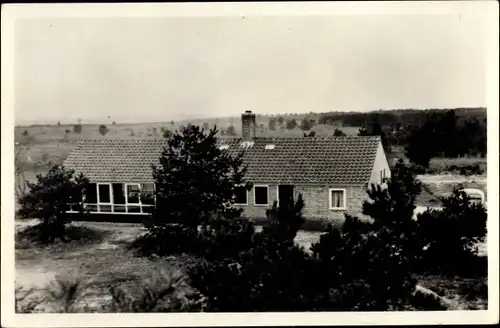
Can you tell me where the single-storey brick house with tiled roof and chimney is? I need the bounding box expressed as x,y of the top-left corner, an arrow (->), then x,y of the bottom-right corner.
65,112 -> 390,226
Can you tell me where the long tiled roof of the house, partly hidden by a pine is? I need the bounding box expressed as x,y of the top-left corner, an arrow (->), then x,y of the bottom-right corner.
65,137 -> 380,186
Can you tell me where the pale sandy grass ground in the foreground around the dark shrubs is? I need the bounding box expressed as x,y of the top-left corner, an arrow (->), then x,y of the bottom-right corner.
15,221 -> 487,312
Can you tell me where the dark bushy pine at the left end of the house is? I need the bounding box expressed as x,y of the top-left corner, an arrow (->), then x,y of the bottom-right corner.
18,165 -> 89,242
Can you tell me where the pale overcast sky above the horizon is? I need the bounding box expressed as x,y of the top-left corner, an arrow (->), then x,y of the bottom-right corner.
15,14 -> 486,124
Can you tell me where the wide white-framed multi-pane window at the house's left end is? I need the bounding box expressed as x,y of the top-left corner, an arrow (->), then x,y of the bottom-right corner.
69,183 -> 155,214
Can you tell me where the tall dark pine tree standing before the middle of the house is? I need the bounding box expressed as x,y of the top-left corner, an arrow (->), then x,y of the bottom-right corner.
148,125 -> 251,227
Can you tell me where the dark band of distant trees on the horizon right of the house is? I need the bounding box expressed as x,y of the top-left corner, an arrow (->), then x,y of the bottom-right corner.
319,108 -> 487,163
